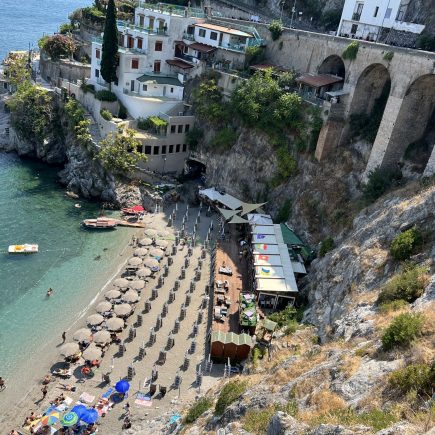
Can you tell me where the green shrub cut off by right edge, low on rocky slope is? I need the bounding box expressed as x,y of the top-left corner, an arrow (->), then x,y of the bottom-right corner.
388,363 -> 435,395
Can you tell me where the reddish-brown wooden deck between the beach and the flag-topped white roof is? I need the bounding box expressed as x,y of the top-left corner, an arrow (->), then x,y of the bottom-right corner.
212,234 -> 249,334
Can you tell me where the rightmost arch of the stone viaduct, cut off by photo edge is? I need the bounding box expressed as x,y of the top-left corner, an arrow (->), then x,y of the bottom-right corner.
378,74 -> 435,172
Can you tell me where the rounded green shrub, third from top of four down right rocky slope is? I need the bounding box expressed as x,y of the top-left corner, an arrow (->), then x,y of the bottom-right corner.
382,313 -> 424,350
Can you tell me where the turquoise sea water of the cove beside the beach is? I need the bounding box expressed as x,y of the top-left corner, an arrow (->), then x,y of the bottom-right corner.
0,154 -> 131,378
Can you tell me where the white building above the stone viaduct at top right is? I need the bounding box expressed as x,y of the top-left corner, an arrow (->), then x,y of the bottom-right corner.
337,0 -> 424,41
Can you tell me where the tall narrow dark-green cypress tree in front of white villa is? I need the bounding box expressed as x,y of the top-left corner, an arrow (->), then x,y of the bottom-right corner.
101,0 -> 118,89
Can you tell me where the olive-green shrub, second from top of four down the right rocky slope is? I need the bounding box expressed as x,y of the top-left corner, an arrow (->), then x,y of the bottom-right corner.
377,264 -> 427,304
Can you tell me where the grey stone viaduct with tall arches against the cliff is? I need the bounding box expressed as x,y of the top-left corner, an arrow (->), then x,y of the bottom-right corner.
247,24 -> 435,176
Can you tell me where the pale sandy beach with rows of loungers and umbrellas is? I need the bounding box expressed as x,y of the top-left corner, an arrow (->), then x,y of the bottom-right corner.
0,204 -> 218,434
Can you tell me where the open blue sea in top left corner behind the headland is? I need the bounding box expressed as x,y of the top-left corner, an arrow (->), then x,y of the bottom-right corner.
0,0 -> 92,60
